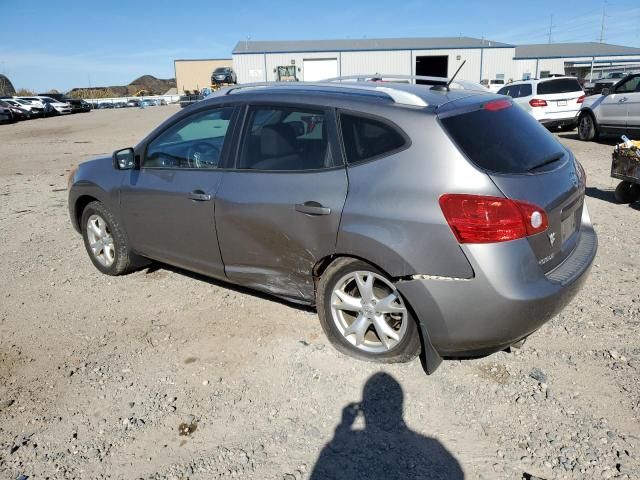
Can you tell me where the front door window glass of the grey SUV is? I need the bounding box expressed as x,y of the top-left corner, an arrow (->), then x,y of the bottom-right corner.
142,107 -> 233,168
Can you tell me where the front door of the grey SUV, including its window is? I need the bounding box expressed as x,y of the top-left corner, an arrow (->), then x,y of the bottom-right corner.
121,107 -> 233,277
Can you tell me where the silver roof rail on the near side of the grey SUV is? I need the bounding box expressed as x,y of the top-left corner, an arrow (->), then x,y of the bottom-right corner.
213,82 -> 429,107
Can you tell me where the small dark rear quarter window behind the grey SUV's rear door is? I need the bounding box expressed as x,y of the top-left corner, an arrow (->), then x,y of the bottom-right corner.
340,114 -> 406,163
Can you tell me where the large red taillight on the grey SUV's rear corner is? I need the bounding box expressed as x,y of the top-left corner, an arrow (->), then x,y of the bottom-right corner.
440,194 -> 549,243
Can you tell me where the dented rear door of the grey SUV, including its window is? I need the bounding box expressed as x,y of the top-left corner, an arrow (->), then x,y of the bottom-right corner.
216,106 -> 347,301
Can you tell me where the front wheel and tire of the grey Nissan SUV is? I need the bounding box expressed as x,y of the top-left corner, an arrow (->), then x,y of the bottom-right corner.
80,201 -> 136,276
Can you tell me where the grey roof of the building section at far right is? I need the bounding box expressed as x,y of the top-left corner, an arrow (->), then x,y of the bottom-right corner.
515,42 -> 640,59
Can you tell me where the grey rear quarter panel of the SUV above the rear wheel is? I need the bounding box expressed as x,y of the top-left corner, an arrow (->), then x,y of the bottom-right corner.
337,108 -> 501,278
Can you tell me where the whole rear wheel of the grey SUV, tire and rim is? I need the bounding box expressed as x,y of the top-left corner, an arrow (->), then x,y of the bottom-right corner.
316,258 -> 421,363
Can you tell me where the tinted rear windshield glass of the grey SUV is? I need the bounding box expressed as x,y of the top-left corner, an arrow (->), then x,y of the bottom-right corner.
440,101 -> 564,174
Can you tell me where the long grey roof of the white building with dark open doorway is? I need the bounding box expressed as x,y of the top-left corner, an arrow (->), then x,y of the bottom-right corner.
233,37 -> 514,55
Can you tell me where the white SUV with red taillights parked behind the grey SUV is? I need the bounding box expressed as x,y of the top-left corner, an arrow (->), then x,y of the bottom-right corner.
498,77 -> 585,130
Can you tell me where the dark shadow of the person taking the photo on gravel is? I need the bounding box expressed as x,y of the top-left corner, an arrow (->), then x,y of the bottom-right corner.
310,373 -> 464,480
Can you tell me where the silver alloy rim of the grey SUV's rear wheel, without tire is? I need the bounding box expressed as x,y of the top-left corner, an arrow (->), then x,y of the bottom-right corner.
331,270 -> 408,354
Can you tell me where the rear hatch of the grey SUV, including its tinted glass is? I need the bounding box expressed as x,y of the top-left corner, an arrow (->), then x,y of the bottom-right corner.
438,97 -> 585,272
